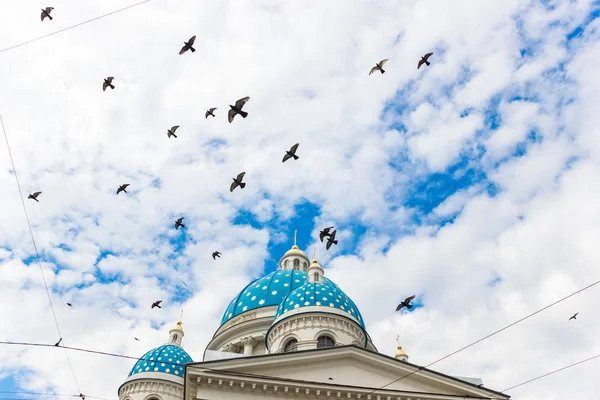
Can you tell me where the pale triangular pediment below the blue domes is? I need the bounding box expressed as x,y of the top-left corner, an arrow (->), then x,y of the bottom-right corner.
187,346 -> 509,399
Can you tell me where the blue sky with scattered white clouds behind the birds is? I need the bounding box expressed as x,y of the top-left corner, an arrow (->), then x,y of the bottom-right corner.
0,0 -> 600,400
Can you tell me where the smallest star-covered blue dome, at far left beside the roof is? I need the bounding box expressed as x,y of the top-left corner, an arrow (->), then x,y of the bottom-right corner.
127,344 -> 193,378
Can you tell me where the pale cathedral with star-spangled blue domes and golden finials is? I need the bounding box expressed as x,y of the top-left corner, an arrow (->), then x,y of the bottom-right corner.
118,244 -> 510,400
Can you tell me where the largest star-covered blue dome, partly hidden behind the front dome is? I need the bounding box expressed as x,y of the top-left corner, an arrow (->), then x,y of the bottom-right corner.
221,270 -> 308,325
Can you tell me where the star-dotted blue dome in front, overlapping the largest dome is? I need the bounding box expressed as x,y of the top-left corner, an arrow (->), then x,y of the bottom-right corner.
275,277 -> 366,329
